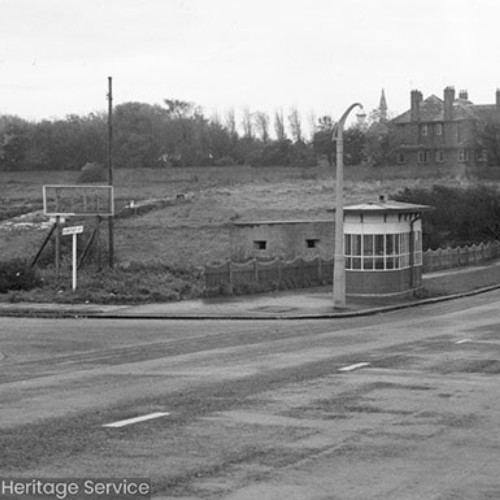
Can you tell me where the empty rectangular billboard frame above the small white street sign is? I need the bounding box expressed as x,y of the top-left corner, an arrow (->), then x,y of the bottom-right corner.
43,185 -> 114,217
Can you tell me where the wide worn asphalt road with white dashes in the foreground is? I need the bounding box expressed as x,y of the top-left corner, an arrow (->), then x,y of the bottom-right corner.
0,292 -> 500,500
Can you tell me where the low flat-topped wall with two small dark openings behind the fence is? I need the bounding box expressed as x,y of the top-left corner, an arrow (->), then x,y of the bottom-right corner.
229,220 -> 335,262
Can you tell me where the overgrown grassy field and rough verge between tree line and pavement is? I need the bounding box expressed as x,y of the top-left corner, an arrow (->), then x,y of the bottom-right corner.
0,167 -> 484,303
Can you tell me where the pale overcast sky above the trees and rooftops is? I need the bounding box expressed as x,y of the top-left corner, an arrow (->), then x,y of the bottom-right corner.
0,0 -> 500,127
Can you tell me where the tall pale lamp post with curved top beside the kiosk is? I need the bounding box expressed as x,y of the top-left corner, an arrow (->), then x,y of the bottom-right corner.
333,102 -> 363,307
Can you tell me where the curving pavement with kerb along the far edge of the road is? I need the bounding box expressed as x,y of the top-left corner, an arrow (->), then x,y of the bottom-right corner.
0,262 -> 500,320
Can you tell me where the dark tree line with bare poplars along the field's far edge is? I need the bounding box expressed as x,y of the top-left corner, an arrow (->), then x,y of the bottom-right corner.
0,99 -> 386,171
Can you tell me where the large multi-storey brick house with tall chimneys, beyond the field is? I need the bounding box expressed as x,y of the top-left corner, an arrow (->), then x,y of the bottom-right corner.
391,87 -> 500,172
